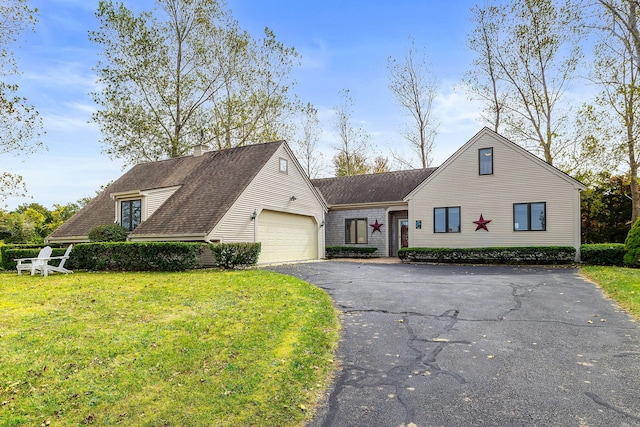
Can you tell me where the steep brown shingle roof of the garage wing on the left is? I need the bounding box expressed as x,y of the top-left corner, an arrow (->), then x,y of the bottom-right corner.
51,141 -> 283,238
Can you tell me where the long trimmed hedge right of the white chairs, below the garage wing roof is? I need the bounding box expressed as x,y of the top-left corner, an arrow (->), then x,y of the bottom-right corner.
67,242 -> 207,271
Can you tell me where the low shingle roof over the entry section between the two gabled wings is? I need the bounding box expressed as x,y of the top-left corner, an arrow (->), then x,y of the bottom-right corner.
311,168 -> 437,206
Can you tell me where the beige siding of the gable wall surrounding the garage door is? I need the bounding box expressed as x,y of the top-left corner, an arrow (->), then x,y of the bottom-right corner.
208,145 -> 325,256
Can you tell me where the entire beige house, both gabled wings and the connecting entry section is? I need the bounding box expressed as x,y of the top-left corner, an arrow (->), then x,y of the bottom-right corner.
47,128 -> 585,264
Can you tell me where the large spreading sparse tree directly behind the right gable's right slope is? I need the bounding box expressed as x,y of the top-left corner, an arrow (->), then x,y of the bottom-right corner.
469,0 -> 582,164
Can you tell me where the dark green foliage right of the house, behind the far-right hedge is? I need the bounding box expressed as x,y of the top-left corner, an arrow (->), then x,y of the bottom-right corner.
581,174 -> 631,243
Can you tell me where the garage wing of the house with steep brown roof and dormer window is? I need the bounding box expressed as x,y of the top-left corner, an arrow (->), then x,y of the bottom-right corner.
47,141 -> 327,263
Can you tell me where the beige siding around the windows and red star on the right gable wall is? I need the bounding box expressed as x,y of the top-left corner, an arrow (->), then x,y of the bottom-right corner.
409,133 -> 580,251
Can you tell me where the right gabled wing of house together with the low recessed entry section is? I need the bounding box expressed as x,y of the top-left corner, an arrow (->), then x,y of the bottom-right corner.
312,128 -> 586,256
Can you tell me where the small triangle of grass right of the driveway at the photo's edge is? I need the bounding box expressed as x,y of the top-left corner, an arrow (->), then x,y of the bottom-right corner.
581,266 -> 640,319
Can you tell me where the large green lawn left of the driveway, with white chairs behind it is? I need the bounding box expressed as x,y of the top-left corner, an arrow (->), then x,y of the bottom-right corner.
0,270 -> 339,426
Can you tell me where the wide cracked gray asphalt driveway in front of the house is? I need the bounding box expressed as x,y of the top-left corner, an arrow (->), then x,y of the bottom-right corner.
272,262 -> 640,427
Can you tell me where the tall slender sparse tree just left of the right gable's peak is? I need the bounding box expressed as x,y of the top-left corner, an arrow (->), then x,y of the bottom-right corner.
387,40 -> 439,168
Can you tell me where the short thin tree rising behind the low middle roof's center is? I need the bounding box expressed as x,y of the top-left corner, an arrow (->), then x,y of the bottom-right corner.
333,89 -> 369,176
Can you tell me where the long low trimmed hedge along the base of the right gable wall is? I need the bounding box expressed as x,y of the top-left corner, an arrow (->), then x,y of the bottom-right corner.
398,246 -> 576,264
